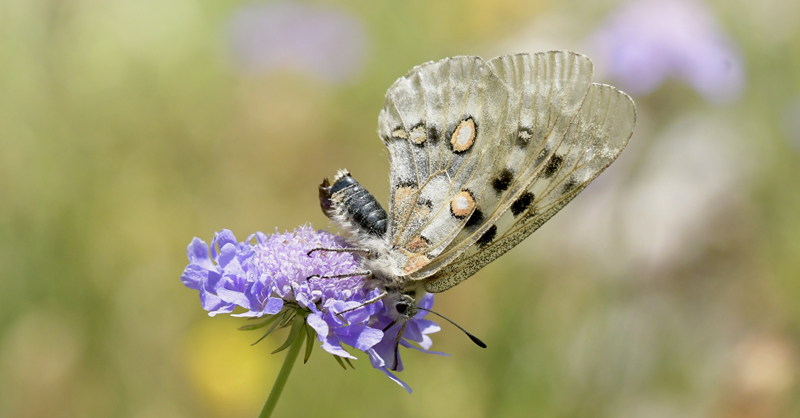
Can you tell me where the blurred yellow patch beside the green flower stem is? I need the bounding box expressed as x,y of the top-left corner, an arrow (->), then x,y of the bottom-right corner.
184,317 -> 282,416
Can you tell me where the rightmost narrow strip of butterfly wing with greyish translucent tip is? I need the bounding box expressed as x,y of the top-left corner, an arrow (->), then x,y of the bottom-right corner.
425,80 -> 636,292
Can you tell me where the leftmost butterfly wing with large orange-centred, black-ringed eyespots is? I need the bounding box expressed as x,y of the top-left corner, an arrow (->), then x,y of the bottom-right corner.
379,57 -> 508,275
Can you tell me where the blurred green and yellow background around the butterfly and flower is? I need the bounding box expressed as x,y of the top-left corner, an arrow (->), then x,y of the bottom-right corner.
0,0 -> 800,418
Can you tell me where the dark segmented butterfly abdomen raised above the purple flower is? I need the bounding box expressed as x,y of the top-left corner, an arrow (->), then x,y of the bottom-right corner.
320,171 -> 387,238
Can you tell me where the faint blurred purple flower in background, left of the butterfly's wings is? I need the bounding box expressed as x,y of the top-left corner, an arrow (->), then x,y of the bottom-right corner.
227,3 -> 367,82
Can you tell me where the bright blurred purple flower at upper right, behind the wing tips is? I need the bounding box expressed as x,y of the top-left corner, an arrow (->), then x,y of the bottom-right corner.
590,0 -> 745,102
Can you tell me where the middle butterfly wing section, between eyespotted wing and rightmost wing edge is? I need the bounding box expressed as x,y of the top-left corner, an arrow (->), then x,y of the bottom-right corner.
411,51 -> 592,279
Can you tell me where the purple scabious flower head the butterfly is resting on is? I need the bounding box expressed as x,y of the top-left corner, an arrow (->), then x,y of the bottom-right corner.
181,226 -> 441,392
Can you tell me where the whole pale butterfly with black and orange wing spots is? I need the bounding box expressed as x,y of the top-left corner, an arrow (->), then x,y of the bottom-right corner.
312,51 -> 636,352
